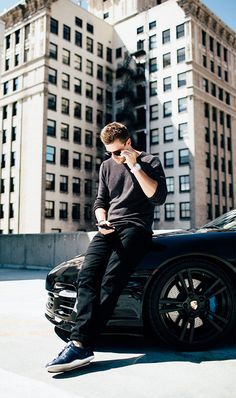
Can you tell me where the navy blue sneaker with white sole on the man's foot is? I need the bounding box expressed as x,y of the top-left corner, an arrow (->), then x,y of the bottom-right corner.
46,341 -> 94,373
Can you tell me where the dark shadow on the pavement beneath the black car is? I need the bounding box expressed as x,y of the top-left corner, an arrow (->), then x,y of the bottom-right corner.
53,336 -> 236,379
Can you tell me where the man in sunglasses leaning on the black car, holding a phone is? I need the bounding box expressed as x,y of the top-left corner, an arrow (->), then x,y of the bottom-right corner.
46,122 -> 167,372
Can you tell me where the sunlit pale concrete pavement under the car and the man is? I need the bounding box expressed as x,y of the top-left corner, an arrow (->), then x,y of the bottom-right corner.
0,269 -> 236,398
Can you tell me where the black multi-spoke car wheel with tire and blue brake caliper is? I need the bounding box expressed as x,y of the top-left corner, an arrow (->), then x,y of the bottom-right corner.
147,258 -> 236,350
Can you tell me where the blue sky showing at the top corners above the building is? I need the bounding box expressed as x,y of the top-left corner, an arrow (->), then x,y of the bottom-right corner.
0,0 -> 236,30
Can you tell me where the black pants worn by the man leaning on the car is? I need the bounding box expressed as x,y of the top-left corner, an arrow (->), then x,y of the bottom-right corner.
70,226 -> 152,345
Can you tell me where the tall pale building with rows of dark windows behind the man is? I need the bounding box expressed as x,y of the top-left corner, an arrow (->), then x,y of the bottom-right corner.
0,0 -> 236,233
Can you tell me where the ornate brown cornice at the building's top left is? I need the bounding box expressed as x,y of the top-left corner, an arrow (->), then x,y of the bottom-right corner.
0,0 -> 57,29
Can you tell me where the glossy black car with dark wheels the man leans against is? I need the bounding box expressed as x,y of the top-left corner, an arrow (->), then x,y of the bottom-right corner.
46,210 -> 236,350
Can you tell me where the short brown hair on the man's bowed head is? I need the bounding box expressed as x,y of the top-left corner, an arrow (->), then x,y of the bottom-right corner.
100,122 -> 130,145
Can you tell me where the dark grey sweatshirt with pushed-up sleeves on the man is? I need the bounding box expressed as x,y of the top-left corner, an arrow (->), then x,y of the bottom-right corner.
94,152 -> 167,231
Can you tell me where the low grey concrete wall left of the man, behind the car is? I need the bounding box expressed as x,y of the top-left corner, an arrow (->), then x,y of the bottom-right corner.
0,232 -> 95,268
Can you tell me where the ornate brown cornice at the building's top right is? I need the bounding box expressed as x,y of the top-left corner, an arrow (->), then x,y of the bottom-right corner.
177,0 -> 236,50
